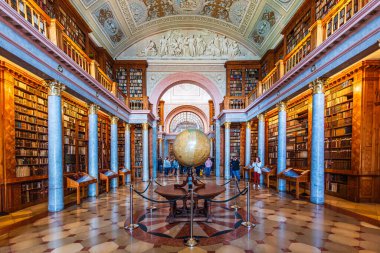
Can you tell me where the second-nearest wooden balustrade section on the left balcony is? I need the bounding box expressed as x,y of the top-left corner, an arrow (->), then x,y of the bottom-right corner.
61,33 -> 91,74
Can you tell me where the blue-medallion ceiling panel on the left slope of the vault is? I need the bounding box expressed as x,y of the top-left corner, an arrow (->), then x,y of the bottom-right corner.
93,3 -> 125,46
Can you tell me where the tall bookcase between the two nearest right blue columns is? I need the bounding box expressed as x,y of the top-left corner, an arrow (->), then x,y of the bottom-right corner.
286,97 -> 310,168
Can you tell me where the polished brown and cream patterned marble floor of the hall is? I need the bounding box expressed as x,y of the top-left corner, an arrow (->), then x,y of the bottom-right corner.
0,178 -> 380,253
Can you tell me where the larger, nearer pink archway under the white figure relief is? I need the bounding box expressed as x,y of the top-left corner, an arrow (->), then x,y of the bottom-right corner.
149,72 -> 223,120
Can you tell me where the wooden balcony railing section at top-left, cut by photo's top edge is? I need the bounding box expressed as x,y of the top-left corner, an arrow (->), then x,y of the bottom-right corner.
5,0 -> 50,37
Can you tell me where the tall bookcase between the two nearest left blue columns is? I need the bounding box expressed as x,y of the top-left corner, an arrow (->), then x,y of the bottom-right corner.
62,96 -> 88,173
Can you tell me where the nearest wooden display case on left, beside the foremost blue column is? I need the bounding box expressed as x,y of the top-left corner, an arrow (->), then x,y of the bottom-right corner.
65,172 -> 98,205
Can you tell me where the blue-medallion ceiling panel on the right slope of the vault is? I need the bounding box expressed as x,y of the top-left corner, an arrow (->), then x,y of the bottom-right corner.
251,5 -> 281,45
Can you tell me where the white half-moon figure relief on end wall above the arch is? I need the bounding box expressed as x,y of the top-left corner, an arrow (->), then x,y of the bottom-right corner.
119,30 -> 258,60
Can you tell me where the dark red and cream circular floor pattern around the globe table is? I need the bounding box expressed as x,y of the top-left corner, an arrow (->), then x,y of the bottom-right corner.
125,206 -> 255,246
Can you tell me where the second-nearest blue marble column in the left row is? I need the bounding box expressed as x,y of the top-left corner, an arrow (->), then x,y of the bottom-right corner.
88,104 -> 99,197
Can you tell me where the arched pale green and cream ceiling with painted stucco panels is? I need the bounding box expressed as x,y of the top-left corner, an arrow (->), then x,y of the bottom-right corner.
71,0 -> 302,59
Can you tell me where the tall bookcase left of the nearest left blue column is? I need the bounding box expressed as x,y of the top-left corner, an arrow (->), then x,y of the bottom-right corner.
14,81 -> 48,177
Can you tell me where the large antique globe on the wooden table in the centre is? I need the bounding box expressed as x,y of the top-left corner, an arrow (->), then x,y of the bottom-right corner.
173,129 -> 210,167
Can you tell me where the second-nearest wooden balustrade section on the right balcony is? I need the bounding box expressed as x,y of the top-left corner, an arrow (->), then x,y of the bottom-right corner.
284,33 -> 312,72
